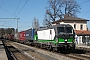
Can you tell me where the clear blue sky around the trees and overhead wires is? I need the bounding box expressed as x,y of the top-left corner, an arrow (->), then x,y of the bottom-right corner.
0,0 -> 90,31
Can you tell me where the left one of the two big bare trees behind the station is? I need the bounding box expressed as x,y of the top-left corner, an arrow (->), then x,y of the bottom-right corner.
46,0 -> 58,21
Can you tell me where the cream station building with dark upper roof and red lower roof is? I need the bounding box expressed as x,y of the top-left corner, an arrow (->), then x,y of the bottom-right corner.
52,16 -> 90,44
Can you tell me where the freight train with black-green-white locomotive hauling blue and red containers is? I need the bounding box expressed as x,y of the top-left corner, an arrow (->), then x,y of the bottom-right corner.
4,24 -> 75,51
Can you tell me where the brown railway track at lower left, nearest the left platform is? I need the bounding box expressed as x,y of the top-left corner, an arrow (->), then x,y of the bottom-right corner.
8,46 -> 31,60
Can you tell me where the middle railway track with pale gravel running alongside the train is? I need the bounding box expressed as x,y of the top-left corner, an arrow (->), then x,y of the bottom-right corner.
4,42 -> 73,60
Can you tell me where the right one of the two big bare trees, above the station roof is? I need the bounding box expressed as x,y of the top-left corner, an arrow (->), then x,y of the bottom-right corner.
63,0 -> 80,16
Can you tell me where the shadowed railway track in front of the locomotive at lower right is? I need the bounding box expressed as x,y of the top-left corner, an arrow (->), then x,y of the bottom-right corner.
53,49 -> 90,60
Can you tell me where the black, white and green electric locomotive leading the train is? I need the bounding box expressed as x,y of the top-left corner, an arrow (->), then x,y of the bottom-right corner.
34,24 -> 75,51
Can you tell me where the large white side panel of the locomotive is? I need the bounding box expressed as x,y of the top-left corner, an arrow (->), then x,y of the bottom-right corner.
37,29 -> 55,40
